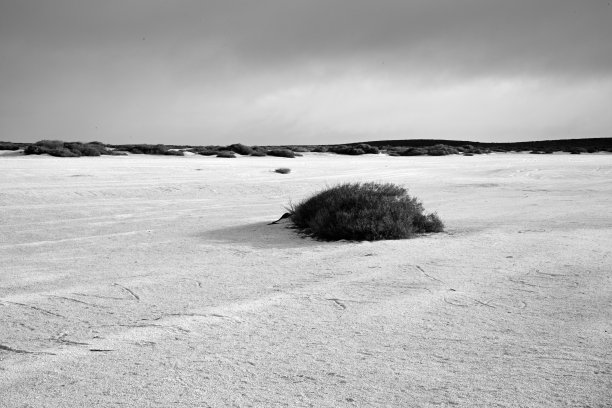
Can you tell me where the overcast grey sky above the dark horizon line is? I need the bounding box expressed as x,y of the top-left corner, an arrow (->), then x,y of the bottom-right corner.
0,0 -> 612,145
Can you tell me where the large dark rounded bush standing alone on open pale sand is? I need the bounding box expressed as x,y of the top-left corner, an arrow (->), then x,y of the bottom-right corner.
290,183 -> 444,241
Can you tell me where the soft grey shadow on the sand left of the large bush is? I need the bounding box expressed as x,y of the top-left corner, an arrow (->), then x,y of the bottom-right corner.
198,222 -> 328,249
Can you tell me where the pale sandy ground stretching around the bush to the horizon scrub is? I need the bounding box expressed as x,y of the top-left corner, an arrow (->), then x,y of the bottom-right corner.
0,154 -> 612,407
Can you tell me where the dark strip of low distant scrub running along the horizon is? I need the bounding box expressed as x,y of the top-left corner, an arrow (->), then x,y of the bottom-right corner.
0,138 -> 612,158
